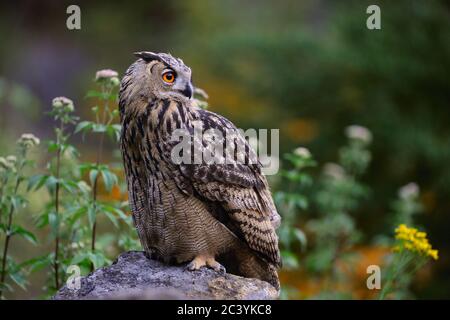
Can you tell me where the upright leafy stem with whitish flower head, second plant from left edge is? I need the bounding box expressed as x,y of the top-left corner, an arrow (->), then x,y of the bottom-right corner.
28,97 -> 87,293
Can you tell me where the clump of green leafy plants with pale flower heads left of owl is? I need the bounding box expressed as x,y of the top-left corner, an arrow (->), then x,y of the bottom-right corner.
11,70 -> 138,297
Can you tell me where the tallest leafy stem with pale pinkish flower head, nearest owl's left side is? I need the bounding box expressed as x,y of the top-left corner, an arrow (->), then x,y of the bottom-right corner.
72,69 -> 135,271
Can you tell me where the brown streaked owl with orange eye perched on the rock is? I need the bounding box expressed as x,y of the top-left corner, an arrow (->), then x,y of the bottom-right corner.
119,51 -> 281,289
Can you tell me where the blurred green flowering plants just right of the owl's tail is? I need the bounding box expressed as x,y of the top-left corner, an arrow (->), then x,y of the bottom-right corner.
275,126 -> 370,298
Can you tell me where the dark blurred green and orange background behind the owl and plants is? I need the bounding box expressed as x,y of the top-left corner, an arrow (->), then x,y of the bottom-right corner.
0,0 -> 450,298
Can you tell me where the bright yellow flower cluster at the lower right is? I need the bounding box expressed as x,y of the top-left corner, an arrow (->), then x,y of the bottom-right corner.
394,224 -> 439,260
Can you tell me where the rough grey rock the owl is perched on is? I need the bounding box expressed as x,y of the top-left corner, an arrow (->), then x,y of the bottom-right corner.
53,251 -> 279,300
